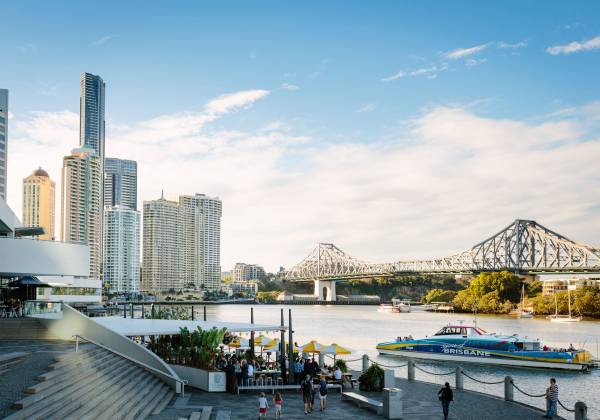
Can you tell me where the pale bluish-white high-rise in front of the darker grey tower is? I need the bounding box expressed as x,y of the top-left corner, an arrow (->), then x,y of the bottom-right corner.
102,206 -> 140,293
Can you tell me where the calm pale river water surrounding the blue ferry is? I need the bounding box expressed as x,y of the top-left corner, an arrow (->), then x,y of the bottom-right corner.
207,305 -> 600,419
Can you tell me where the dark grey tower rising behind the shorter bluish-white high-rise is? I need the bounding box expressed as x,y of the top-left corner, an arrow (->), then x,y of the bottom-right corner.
104,158 -> 137,210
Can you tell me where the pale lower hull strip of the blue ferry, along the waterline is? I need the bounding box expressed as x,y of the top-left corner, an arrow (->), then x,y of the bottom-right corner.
378,349 -> 588,371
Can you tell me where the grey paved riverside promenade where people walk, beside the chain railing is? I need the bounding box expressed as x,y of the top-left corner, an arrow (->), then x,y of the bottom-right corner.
152,378 -> 544,420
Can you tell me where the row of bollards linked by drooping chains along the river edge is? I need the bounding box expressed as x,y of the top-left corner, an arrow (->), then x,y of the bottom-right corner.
356,354 -> 587,420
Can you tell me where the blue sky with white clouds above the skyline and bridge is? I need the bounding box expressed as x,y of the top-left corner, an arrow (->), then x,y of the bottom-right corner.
0,1 -> 600,271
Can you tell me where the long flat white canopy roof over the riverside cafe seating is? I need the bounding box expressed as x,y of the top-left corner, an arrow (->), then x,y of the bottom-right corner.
94,316 -> 286,337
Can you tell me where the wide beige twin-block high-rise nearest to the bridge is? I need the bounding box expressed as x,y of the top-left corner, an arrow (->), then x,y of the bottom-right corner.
142,194 -> 222,291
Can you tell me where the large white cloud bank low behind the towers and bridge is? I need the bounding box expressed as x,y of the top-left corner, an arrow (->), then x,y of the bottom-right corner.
8,94 -> 600,270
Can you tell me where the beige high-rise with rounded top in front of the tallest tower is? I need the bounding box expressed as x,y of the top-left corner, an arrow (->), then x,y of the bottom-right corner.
60,147 -> 103,279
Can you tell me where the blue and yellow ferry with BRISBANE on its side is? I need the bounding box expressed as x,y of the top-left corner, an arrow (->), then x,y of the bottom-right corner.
377,324 -> 592,371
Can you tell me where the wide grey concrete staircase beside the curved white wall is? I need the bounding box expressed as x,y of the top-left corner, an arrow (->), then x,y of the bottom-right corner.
5,344 -> 175,420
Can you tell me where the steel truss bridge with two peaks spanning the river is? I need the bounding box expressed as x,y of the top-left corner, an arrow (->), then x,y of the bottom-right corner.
281,219 -> 600,301
